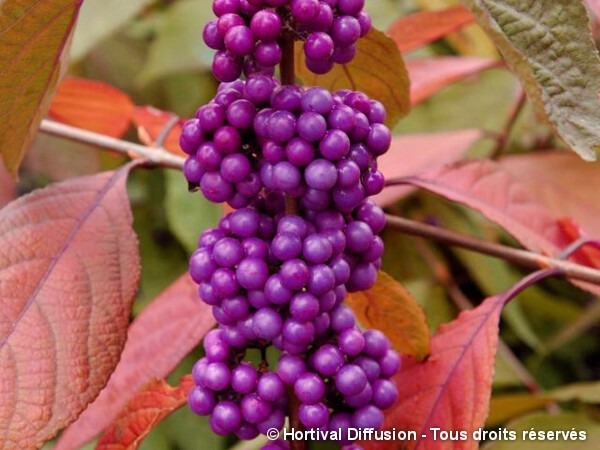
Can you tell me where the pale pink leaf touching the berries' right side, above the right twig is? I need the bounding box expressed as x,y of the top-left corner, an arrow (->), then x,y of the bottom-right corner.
374,130 -> 483,206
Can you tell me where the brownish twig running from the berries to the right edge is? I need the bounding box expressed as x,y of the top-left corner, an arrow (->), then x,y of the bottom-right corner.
387,215 -> 600,285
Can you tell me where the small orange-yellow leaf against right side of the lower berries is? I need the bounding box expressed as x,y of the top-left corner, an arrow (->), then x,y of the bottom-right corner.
347,271 -> 429,360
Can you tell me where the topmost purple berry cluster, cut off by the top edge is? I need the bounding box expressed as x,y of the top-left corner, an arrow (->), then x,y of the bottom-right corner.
203,0 -> 371,82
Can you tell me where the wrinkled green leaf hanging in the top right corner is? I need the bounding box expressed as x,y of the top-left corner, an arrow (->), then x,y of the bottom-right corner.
463,0 -> 600,160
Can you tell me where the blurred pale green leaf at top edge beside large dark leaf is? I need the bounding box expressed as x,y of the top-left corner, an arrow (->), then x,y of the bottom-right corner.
71,0 -> 154,61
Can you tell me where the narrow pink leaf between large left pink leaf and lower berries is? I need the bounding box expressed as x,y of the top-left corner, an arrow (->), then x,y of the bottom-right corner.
55,274 -> 215,450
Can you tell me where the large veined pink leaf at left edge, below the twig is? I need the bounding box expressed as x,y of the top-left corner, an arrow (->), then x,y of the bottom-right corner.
0,167 -> 140,450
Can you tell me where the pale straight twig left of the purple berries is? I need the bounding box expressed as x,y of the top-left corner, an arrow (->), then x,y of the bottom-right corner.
40,120 -> 185,170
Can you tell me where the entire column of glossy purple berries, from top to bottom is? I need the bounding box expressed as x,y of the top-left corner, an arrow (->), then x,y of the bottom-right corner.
180,0 -> 400,450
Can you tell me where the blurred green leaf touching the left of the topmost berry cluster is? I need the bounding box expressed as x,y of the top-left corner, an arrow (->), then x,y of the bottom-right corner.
137,0 -> 214,84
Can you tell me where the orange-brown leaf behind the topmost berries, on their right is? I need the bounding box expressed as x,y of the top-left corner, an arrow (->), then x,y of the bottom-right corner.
296,29 -> 410,127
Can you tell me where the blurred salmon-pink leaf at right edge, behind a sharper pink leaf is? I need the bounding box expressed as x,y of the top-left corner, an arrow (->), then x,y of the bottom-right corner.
500,151 -> 600,238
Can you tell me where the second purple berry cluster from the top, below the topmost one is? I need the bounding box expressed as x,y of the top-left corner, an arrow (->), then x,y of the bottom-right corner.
181,75 -> 391,213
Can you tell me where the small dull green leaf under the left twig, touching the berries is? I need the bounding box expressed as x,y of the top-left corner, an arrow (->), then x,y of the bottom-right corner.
165,170 -> 221,252
